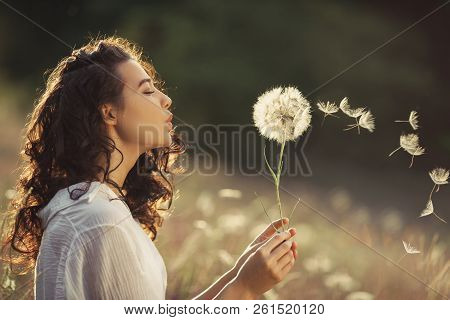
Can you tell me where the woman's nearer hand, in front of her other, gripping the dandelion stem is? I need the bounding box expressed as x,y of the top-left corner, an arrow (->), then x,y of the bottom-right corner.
235,228 -> 295,297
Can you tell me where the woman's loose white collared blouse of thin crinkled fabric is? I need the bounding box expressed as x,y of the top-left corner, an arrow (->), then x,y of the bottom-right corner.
34,181 -> 167,300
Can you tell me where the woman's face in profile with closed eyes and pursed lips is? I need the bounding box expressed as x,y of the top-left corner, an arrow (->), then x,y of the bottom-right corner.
116,60 -> 173,154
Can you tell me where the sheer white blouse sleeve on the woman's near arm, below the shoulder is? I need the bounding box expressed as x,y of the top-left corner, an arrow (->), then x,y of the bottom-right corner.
65,225 -> 161,300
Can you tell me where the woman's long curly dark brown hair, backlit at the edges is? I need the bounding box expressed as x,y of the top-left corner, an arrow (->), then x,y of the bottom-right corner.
2,36 -> 186,274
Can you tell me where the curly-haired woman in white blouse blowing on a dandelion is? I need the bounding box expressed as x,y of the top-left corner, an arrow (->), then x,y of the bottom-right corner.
3,37 -> 297,299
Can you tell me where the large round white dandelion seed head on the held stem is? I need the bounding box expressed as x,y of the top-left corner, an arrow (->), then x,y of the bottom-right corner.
253,87 -> 311,143
